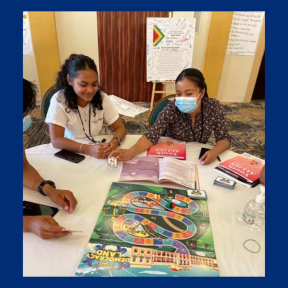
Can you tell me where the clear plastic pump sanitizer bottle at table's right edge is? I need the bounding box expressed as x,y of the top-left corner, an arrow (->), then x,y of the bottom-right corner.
243,186 -> 265,228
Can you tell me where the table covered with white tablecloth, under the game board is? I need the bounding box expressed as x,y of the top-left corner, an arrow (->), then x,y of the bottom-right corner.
23,135 -> 265,276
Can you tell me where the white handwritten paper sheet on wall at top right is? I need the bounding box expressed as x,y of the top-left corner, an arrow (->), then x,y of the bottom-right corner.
226,12 -> 264,55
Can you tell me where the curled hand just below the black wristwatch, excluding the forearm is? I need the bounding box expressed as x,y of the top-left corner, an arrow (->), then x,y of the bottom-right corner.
43,185 -> 78,213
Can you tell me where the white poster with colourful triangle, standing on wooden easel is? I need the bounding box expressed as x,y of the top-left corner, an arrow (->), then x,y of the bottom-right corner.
146,18 -> 196,82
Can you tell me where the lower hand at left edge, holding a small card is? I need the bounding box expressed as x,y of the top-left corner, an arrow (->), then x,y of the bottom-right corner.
23,216 -> 72,239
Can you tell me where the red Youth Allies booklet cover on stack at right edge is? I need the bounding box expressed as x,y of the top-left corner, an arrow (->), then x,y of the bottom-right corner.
219,153 -> 264,183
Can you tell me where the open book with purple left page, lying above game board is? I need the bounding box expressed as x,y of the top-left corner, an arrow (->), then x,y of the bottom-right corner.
119,157 -> 199,189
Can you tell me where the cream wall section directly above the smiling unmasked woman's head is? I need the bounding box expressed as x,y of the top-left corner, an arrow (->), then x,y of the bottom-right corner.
55,11 -> 99,79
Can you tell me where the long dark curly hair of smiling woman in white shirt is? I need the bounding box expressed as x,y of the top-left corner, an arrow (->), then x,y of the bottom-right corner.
56,54 -> 103,116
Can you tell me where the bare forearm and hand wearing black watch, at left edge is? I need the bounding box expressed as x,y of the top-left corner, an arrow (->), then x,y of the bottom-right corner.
23,148 -> 77,213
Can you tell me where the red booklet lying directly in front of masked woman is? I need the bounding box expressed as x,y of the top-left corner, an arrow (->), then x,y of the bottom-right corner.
147,139 -> 186,160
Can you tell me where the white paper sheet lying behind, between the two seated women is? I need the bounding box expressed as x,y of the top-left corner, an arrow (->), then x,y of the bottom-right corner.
110,95 -> 149,118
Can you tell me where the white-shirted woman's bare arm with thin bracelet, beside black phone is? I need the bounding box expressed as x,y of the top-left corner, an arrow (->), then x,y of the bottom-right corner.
49,123 -> 109,159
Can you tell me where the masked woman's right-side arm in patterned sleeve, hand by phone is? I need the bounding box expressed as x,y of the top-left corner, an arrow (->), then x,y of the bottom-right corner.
199,101 -> 231,165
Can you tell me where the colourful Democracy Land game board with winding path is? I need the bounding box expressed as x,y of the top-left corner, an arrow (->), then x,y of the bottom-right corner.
75,182 -> 219,277
